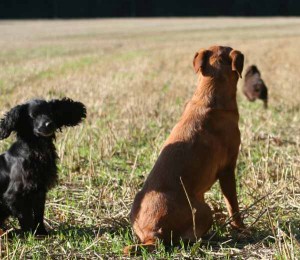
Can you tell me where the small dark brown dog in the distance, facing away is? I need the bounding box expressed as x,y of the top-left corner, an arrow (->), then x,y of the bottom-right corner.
243,65 -> 268,108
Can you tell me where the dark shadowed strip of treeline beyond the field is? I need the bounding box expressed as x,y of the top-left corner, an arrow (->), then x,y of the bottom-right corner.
0,0 -> 300,19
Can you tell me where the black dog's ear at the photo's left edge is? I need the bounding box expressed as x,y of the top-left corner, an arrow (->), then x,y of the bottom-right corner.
0,105 -> 26,140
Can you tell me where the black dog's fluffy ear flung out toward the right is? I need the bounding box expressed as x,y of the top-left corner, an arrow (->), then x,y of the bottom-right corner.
49,98 -> 86,128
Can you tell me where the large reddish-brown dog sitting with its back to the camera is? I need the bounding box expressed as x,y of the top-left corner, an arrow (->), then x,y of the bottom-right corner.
124,46 -> 244,253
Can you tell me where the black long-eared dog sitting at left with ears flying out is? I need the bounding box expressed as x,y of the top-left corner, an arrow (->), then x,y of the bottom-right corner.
0,98 -> 86,235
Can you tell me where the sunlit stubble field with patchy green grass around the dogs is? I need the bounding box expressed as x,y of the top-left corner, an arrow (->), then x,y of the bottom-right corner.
0,18 -> 300,259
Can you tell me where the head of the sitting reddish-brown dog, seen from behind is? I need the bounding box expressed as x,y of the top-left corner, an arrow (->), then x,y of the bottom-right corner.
193,46 -> 244,80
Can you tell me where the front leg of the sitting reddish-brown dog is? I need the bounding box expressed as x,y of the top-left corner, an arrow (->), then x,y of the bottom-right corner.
219,169 -> 245,229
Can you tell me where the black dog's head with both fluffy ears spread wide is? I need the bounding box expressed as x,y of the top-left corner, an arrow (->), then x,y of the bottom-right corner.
0,98 -> 86,139
